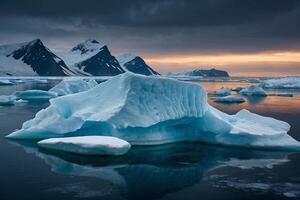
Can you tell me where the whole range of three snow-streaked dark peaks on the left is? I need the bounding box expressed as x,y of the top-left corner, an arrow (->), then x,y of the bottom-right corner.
0,39 -> 159,76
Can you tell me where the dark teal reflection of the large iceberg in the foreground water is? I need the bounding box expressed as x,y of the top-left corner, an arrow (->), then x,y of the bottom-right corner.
11,141 -> 289,199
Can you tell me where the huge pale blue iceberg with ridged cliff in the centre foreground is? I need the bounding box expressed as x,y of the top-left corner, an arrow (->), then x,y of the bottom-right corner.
7,73 -> 300,150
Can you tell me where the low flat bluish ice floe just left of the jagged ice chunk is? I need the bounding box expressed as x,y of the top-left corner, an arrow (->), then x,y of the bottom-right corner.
15,90 -> 57,101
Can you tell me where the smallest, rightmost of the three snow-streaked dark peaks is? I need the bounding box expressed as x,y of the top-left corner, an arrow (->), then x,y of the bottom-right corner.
117,54 -> 159,76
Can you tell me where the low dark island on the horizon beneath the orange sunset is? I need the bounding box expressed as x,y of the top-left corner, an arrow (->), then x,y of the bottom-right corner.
169,68 -> 229,77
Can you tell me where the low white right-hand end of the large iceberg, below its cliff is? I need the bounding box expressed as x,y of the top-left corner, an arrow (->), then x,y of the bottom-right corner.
201,106 -> 300,151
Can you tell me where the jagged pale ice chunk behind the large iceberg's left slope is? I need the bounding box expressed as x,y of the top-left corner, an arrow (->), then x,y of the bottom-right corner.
49,78 -> 98,96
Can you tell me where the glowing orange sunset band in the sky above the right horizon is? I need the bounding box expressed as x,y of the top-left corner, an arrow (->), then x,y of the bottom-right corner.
146,51 -> 300,76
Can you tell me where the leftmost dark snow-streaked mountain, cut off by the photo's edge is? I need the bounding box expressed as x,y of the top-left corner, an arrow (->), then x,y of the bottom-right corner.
0,39 -> 73,76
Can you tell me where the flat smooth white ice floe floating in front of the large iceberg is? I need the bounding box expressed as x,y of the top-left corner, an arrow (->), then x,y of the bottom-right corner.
38,136 -> 130,156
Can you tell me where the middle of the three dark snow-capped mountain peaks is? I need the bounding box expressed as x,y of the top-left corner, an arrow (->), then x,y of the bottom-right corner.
60,39 -> 125,76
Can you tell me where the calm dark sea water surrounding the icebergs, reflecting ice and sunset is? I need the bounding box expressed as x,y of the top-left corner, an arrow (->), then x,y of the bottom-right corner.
0,81 -> 300,200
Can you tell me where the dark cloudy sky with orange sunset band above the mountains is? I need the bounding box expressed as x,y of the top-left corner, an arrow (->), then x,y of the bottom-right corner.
0,0 -> 300,76
